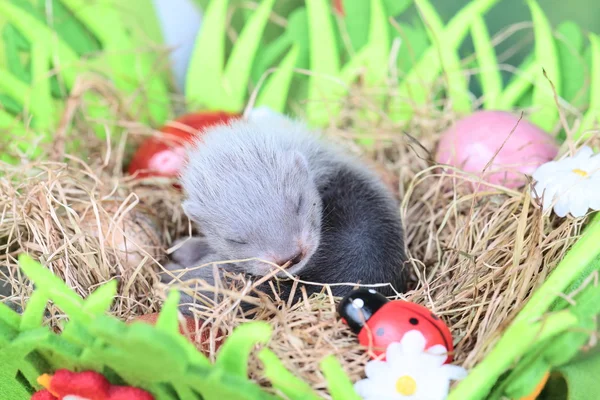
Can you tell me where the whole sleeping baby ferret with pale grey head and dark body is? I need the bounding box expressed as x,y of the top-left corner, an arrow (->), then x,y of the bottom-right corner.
167,115 -> 407,308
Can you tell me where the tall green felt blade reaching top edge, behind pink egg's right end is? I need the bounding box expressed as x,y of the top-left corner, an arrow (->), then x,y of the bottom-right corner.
527,0 -> 562,131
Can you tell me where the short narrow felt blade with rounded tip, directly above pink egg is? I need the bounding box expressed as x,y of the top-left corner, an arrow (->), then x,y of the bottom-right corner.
471,17 -> 502,110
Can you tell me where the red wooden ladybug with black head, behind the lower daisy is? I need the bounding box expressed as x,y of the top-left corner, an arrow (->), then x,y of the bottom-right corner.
338,289 -> 454,363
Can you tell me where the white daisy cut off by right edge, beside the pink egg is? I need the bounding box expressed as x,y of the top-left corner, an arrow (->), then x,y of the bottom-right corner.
533,146 -> 600,218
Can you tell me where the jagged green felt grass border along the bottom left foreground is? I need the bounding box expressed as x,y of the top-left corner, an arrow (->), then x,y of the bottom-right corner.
0,255 -> 356,400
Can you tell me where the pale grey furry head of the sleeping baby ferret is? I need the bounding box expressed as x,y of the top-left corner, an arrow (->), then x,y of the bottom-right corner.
181,118 -> 322,275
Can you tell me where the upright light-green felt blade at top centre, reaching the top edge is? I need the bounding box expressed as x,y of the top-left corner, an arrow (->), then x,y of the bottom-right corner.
306,0 -> 345,126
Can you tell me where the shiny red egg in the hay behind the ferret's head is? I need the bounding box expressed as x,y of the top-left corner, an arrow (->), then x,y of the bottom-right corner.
128,111 -> 239,178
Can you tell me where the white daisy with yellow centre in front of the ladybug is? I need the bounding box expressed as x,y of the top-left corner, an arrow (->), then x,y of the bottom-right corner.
354,330 -> 467,400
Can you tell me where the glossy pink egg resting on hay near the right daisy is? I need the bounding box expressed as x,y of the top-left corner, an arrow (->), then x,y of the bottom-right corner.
435,111 -> 558,190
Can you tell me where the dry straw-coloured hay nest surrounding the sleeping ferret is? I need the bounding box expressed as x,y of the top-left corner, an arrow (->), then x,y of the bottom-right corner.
0,86 -> 582,398
